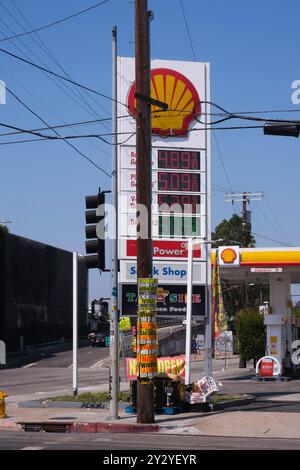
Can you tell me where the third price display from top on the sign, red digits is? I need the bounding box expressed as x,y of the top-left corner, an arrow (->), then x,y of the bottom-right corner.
157,194 -> 200,214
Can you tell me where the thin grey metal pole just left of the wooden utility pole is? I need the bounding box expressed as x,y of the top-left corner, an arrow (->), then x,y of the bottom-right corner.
109,26 -> 119,419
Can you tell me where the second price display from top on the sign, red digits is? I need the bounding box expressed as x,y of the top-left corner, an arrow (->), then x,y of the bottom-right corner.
158,172 -> 200,193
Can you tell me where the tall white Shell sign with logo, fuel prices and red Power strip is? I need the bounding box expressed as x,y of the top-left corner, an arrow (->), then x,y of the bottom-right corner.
118,57 -> 211,315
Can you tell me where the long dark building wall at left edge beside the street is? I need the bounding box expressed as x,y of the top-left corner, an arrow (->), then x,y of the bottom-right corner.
0,230 -> 88,352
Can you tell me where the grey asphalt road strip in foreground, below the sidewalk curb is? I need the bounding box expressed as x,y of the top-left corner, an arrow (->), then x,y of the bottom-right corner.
0,431 -> 300,455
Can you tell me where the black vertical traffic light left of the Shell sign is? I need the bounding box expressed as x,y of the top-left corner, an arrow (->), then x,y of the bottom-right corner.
85,189 -> 106,271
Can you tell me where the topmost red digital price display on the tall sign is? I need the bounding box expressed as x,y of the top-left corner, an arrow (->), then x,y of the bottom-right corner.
158,150 -> 200,170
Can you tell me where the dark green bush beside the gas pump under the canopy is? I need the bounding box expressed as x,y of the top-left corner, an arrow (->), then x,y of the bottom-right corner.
235,308 -> 266,366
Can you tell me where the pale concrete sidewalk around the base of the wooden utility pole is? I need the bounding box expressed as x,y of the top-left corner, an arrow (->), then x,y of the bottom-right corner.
0,371 -> 300,439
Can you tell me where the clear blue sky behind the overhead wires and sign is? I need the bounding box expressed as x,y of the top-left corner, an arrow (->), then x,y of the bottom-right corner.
0,0 -> 300,297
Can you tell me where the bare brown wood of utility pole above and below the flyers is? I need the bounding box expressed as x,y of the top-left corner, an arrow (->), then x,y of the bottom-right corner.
135,0 -> 154,423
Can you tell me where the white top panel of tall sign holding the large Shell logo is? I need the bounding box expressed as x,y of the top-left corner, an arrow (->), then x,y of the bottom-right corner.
118,57 -> 210,149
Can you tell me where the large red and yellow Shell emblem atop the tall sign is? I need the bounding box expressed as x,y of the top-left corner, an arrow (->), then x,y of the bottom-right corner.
128,68 -> 201,137
